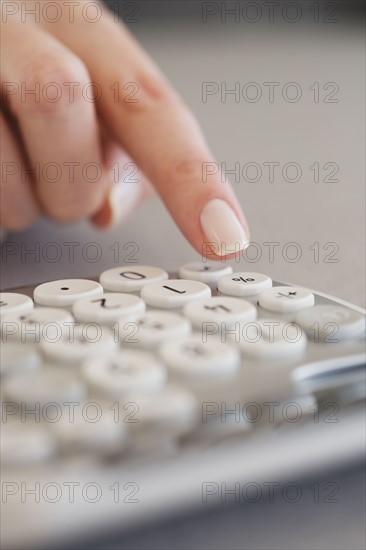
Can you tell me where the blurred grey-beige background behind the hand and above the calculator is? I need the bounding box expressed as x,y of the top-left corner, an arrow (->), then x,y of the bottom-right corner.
1,0 -> 365,305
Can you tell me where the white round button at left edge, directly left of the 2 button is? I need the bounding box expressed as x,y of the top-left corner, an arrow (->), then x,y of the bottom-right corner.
1,307 -> 74,344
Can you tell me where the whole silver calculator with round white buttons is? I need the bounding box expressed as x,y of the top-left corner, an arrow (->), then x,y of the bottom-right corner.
0,261 -> 365,548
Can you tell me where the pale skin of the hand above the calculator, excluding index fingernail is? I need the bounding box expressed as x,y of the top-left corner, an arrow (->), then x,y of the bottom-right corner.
0,0 -> 249,259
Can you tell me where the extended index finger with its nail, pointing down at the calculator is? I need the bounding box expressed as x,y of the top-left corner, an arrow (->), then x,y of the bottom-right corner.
42,8 -> 249,258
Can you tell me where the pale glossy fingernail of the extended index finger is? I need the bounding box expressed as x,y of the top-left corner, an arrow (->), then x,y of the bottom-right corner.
200,199 -> 249,256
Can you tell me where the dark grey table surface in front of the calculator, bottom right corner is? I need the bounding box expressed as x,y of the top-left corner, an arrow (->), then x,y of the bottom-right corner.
78,466 -> 366,550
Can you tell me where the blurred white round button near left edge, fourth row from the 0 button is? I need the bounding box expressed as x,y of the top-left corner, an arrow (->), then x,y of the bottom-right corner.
3,365 -> 86,407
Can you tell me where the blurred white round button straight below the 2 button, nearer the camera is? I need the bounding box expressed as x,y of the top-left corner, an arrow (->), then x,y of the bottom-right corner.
82,349 -> 166,399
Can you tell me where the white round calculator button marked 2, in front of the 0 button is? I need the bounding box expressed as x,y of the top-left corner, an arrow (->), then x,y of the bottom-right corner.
72,292 -> 146,324
